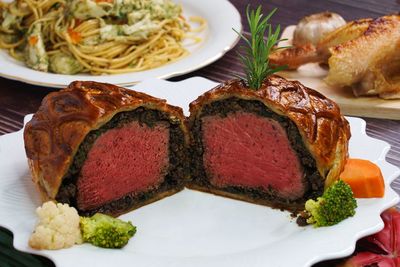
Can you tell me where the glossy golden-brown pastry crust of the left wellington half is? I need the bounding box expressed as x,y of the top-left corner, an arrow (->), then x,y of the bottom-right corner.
24,81 -> 189,200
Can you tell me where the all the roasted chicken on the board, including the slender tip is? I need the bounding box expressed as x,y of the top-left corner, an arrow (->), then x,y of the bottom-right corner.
269,15 -> 400,99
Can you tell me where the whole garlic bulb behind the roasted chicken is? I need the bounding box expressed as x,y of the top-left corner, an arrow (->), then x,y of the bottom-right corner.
293,12 -> 346,46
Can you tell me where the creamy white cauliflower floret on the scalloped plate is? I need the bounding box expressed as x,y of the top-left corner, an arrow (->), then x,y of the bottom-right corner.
29,201 -> 82,249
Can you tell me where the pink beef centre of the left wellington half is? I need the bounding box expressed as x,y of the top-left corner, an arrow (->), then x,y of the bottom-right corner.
77,121 -> 169,210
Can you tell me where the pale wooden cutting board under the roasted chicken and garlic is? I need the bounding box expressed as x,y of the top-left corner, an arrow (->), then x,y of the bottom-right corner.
279,25 -> 400,120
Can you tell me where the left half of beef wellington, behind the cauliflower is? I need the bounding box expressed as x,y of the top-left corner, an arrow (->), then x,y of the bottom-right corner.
24,82 -> 188,215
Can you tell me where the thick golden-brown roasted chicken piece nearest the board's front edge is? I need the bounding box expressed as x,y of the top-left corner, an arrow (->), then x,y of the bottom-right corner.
326,15 -> 400,99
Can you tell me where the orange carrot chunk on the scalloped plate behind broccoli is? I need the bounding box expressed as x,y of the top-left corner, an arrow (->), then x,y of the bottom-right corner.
340,159 -> 385,198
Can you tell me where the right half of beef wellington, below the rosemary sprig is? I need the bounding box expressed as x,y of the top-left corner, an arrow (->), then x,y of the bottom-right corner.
188,75 -> 350,211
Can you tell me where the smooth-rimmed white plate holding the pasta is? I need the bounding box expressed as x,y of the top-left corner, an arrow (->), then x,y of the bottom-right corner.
0,0 -> 242,87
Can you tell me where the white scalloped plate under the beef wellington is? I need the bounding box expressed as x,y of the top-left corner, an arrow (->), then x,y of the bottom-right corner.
0,78 -> 400,267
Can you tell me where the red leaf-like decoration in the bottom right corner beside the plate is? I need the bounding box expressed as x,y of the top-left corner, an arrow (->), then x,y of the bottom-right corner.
340,208 -> 400,267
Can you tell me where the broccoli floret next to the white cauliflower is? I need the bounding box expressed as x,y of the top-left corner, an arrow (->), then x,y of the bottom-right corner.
80,213 -> 136,248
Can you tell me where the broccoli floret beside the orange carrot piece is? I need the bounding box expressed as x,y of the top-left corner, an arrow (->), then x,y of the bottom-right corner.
305,180 -> 357,227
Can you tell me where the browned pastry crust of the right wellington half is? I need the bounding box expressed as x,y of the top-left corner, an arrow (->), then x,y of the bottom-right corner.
190,75 -> 350,187
